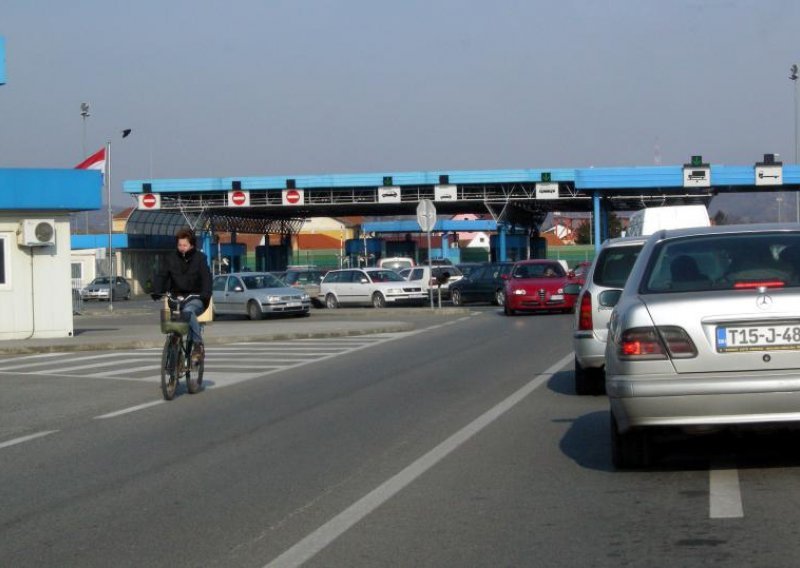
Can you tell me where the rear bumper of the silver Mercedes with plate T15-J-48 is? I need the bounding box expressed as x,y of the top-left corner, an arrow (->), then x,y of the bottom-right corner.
606,369 -> 800,431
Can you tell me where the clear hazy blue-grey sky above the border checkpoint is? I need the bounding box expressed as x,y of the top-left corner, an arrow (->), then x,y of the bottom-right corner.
0,0 -> 800,205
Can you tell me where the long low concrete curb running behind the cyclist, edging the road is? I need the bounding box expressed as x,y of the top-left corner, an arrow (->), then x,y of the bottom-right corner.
0,322 -> 415,355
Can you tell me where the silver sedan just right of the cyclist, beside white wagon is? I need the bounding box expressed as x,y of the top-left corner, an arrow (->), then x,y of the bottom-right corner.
212,272 -> 311,320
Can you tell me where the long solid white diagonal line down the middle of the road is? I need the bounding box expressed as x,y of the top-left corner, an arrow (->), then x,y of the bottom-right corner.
266,353 -> 573,568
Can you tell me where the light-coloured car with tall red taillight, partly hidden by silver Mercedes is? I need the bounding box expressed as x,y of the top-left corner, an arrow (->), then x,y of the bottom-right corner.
572,237 -> 648,395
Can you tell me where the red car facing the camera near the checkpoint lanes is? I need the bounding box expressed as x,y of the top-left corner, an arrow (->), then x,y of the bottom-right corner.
504,259 -> 581,316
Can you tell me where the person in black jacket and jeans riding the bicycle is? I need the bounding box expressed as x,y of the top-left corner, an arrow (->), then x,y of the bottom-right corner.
152,229 -> 211,360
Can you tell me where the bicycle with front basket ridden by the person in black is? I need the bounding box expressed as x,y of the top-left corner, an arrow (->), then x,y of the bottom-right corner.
161,293 -> 205,400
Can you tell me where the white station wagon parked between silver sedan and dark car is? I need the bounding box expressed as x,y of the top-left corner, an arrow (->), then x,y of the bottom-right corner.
319,268 -> 427,309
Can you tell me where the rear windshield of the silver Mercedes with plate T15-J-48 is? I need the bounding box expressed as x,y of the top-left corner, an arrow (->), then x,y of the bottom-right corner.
640,231 -> 800,294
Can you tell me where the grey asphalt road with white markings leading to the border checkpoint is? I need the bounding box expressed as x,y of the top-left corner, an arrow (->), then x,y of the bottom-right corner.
0,308 -> 800,567
